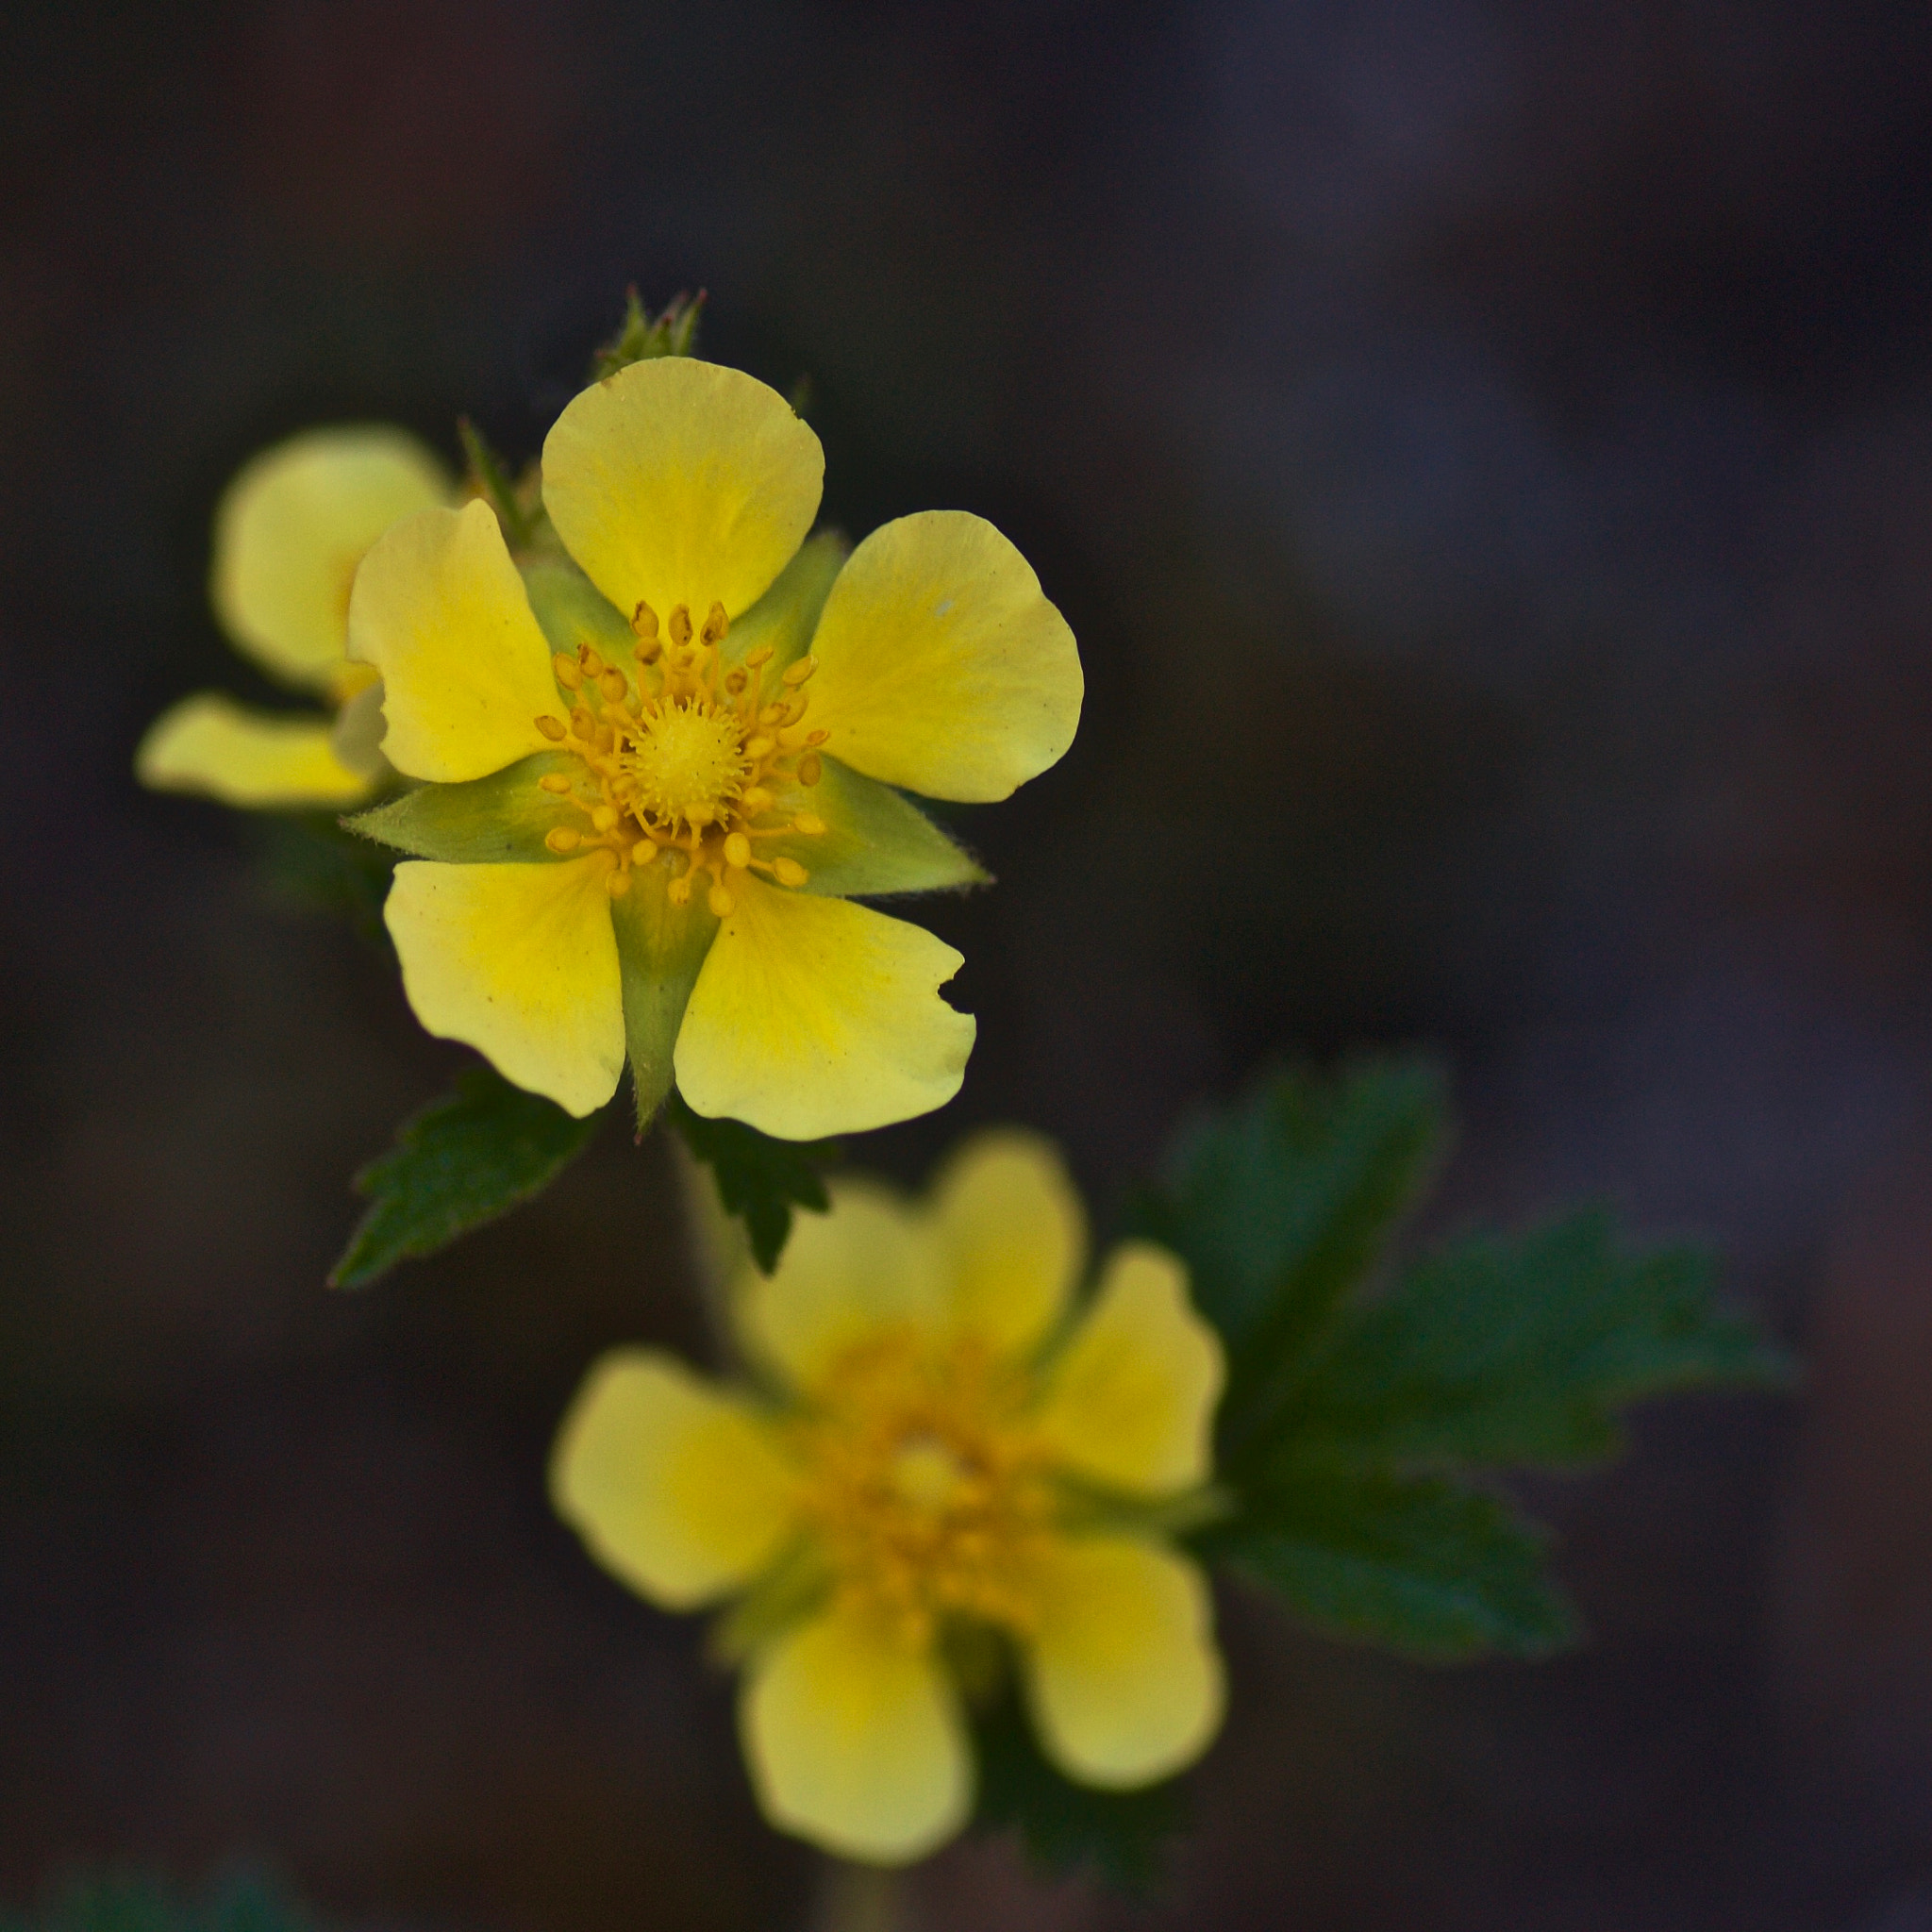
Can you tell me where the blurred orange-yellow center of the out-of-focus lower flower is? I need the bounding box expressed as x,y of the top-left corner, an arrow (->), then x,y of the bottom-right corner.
798,1333 -> 1057,1648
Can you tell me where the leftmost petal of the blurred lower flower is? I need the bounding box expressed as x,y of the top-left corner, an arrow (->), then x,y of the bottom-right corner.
551,1349 -> 794,1609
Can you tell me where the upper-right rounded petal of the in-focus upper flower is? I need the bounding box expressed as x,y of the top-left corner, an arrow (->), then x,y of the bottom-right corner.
811,510 -> 1084,800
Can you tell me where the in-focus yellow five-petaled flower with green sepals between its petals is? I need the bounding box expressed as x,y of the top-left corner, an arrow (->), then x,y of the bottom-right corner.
350,358 -> 1082,1140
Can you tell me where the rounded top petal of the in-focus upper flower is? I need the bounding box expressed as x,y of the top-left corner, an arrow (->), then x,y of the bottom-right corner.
542,356 -> 824,625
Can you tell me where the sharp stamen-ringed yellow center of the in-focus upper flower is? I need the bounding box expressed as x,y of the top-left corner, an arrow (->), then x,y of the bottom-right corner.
537,603 -> 827,920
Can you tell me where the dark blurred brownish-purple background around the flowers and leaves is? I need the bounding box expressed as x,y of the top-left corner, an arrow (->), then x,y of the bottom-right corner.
0,0 -> 1932,1932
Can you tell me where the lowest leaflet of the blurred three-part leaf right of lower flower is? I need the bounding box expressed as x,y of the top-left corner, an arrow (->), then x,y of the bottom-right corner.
1198,1457 -> 1576,1661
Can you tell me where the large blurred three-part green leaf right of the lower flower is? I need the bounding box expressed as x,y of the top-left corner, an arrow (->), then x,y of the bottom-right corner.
1136,1060 -> 1790,1657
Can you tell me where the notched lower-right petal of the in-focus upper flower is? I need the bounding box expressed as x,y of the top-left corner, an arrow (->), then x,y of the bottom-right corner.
675,880 -> 974,1140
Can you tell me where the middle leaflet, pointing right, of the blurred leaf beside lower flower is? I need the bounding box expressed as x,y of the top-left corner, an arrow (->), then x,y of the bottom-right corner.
1289,1209 -> 1790,1466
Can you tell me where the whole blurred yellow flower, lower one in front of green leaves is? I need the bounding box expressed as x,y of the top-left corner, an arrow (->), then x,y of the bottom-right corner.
551,1134 -> 1223,1864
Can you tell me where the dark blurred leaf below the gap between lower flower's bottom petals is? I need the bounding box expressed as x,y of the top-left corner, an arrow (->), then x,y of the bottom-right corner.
974,1694 -> 1186,1897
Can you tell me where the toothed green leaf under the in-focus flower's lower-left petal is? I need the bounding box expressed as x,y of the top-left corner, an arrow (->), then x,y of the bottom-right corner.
328,1066 -> 601,1289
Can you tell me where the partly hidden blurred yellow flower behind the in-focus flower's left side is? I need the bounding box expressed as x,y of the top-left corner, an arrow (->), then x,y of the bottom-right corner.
135,425 -> 454,808
